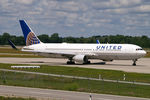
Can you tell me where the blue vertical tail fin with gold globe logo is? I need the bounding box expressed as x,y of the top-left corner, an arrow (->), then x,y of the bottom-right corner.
19,20 -> 41,46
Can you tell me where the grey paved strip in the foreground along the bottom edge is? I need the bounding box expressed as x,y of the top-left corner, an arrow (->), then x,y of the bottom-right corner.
0,85 -> 150,100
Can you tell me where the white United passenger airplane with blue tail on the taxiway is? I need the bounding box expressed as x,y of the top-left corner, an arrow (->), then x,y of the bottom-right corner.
19,20 -> 146,66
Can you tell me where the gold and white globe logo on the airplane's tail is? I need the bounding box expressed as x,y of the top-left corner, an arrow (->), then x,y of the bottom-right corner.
26,32 -> 40,46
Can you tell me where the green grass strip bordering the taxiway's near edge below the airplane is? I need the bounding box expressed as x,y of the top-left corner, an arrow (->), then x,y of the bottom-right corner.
0,64 -> 150,83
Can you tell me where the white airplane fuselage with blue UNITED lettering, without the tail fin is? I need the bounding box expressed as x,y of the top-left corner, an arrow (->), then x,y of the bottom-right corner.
22,43 -> 146,61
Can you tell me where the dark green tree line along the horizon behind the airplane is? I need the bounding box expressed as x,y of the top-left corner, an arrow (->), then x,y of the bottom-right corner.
0,33 -> 150,48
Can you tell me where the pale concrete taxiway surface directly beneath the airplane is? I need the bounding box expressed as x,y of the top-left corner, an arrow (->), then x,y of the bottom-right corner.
0,57 -> 150,73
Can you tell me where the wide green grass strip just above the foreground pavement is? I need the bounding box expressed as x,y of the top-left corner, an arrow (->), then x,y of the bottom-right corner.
0,71 -> 150,98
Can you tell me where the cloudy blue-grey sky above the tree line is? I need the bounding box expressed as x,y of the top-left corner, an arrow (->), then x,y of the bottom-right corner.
0,0 -> 150,37
